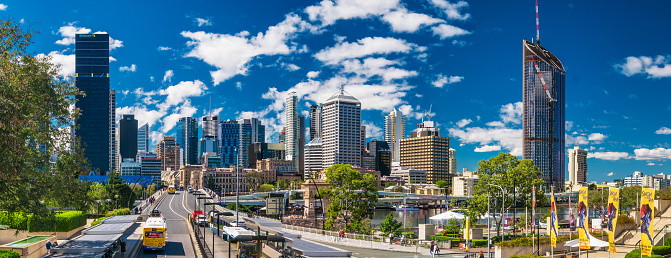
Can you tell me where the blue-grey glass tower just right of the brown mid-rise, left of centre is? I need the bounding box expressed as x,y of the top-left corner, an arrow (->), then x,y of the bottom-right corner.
176,117 -> 198,165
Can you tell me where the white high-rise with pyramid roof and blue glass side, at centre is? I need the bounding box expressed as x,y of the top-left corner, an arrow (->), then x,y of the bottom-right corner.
322,89 -> 361,169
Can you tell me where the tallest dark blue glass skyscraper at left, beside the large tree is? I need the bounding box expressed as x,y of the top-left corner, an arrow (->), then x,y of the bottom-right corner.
75,34 -> 111,175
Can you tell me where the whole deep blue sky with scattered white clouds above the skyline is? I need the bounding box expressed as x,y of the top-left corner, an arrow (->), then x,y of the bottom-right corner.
0,0 -> 671,182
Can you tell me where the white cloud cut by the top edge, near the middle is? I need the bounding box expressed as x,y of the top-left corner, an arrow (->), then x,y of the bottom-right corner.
305,0 -> 400,26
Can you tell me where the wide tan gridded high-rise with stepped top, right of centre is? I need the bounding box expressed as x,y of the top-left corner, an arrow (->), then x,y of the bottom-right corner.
400,121 -> 452,185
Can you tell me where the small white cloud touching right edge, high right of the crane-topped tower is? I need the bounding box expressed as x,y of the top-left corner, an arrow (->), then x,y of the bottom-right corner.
614,55 -> 671,78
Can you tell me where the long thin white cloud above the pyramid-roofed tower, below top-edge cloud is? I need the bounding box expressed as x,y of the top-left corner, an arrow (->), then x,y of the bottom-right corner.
315,37 -> 417,64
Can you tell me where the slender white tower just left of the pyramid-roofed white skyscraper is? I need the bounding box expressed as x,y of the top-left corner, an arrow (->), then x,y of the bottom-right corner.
285,92 -> 302,171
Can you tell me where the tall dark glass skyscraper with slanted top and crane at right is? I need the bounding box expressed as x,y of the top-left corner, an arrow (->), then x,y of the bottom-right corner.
522,40 -> 566,189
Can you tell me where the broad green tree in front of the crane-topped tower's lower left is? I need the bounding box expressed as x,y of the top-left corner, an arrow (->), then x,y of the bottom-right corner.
466,153 -> 544,239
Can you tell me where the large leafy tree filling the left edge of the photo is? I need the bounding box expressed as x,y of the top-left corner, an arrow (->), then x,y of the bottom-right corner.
0,20 -> 90,216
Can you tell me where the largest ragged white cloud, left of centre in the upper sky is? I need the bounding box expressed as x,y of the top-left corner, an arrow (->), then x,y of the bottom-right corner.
181,14 -> 314,86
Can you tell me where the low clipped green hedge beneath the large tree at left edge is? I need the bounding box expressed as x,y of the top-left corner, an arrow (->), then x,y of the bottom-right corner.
0,211 -> 86,232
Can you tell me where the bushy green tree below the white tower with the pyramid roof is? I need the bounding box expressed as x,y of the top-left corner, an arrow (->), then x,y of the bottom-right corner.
319,164 -> 377,232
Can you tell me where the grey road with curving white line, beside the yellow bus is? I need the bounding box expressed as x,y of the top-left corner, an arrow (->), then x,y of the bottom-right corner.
136,191 -> 196,257
